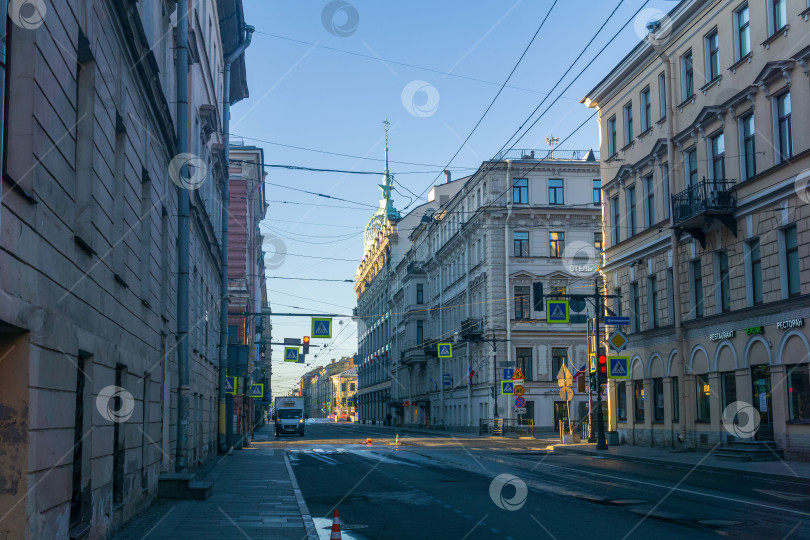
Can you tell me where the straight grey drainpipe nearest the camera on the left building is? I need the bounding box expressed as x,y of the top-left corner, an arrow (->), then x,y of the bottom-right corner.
174,0 -> 189,472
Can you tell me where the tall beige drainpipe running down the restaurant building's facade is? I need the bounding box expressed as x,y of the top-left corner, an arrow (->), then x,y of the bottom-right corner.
648,37 -> 689,447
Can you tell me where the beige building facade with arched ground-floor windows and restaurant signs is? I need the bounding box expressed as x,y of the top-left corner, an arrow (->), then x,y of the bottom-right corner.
584,0 -> 810,459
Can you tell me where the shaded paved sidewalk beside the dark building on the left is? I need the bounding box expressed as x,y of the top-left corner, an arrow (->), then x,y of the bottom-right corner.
113,426 -> 318,540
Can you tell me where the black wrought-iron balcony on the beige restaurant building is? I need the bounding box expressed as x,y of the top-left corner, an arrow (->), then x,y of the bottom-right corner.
672,178 -> 737,248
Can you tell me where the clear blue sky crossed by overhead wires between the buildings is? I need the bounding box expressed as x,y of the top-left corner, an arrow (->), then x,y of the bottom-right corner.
231,0 -> 676,395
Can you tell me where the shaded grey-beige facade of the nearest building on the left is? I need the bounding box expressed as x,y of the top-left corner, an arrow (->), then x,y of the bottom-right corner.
0,0 -> 246,538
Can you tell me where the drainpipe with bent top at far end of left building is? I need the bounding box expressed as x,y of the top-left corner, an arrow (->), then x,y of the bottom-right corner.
218,22 -> 252,453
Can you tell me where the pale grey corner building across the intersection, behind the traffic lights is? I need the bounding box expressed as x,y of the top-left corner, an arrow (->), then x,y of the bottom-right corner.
392,150 -> 601,430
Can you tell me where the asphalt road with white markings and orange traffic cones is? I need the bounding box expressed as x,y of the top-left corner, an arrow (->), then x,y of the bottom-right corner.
270,423 -> 810,539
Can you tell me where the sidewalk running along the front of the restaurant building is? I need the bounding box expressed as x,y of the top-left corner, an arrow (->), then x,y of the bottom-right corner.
549,443 -> 810,482
